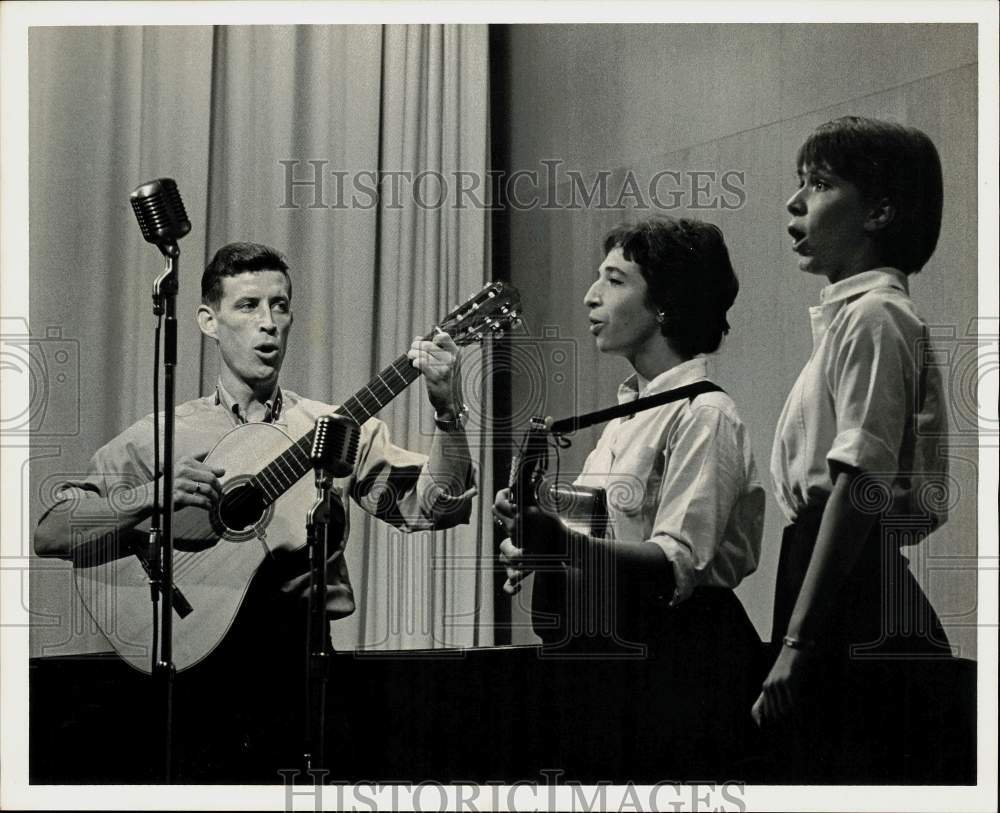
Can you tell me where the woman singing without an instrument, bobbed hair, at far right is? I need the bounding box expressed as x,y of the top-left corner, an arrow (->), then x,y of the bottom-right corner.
753,116 -> 950,781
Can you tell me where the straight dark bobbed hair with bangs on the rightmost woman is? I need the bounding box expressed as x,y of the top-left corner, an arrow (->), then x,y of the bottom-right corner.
796,116 -> 944,274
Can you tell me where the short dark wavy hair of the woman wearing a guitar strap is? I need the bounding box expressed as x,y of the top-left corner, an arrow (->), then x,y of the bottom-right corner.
604,217 -> 740,357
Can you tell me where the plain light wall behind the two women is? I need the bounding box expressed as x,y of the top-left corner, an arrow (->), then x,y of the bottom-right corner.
504,25 -> 977,657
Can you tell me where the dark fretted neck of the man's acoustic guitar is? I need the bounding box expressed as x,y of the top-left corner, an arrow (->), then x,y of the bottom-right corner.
250,354 -> 420,504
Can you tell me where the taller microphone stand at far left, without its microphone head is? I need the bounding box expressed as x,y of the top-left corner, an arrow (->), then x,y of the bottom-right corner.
150,243 -> 180,784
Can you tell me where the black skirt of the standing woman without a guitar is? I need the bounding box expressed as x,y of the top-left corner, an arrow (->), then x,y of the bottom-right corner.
764,511 -> 951,784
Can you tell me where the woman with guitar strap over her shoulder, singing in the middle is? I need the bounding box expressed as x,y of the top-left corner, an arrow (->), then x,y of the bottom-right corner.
494,219 -> 764,772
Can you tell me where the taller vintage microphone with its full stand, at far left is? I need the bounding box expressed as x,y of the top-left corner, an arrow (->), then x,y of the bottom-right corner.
129,178 -> 191,783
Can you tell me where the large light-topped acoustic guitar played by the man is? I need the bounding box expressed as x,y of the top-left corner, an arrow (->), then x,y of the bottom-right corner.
73,282 -> 520,674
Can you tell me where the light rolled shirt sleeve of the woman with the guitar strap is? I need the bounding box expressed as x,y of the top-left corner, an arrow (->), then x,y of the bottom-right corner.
649,405 -> 744,603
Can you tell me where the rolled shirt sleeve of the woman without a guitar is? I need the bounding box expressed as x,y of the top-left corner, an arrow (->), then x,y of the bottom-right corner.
827,307 -> 913,480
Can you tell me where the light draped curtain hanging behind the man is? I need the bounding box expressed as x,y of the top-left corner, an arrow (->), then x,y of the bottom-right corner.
29,25 -> 492,655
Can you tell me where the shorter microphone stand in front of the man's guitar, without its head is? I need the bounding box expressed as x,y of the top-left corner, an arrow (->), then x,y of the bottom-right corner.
303,463 -> 344,774
